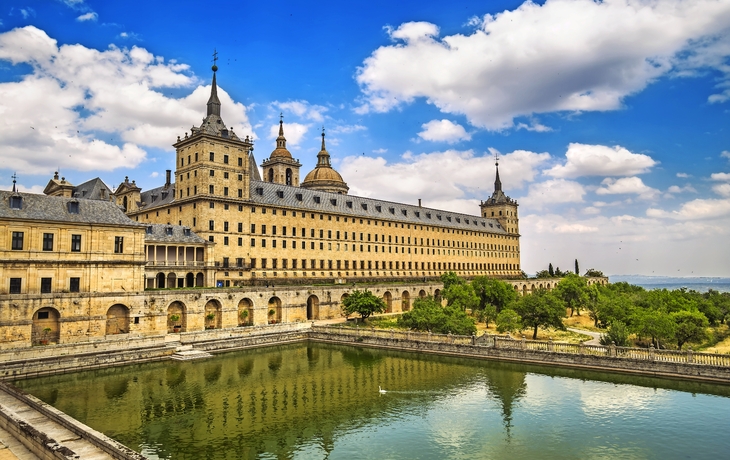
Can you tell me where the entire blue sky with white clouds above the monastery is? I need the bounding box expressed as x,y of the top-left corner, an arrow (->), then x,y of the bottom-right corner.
0,0 -> 730,276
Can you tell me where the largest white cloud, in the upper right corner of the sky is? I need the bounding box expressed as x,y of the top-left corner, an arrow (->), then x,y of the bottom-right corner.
356,0 -> 730,130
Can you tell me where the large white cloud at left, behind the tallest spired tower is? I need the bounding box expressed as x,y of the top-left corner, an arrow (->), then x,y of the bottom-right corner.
0,26 -> 251,174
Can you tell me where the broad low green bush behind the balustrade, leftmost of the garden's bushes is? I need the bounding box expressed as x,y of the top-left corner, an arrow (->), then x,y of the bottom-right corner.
398,296 -> 476,335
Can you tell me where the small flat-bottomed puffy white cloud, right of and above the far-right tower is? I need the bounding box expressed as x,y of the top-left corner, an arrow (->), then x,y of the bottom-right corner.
545,143 -> 657,178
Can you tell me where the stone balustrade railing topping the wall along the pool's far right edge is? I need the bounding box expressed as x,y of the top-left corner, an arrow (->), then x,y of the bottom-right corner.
312,326 -> 730,367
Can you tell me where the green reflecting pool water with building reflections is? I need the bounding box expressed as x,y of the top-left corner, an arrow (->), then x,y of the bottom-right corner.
16,343 -> 730,460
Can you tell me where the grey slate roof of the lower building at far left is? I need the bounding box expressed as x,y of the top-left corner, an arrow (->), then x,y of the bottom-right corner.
0,191 -> 144,227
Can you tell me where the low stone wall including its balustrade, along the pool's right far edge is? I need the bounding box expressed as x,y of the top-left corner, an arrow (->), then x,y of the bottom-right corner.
309,326 -> 730,384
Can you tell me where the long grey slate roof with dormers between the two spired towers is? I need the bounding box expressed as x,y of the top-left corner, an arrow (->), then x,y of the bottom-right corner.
250,180 -> 507,235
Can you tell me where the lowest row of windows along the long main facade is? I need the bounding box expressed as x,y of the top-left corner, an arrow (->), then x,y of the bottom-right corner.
245,258 -> 520,270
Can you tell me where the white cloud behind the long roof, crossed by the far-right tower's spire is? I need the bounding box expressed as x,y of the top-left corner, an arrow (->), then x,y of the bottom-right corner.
340,150 -> 550,214
